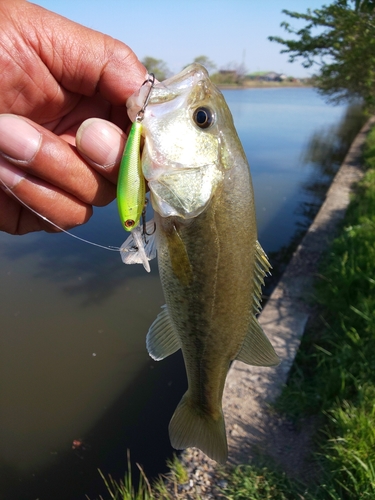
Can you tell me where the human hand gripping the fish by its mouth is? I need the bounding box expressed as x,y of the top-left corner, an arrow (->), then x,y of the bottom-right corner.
0,0 -> 147,234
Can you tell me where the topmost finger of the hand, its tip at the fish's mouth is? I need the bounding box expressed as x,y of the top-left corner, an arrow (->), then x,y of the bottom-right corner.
22,3 -> 147,105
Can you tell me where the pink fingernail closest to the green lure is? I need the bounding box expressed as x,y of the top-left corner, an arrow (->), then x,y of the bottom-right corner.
76,118 -> 125,168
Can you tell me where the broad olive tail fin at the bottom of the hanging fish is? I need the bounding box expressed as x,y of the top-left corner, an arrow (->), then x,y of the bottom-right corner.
169,392 -> 228,464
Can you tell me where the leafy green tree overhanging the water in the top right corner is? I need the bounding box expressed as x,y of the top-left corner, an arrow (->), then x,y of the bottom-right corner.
269,0 -> 375,107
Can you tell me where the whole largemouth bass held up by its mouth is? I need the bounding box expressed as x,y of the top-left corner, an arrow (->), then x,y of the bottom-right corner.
127,64 -> 279,463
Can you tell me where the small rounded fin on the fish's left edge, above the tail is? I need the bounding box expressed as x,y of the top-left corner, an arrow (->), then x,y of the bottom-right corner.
146,306 -> 181,361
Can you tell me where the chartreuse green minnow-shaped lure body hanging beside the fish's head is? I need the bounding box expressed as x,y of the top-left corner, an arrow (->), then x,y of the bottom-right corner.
117,121 -> 146,231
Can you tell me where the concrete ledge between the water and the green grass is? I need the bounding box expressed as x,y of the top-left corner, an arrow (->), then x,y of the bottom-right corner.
173,117 -> 375,500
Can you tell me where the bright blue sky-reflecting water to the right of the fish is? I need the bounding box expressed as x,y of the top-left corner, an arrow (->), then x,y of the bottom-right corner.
225,88 -> 345,252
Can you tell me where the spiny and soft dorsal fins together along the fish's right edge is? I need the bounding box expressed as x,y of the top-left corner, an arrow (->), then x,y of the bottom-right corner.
236,241 -> 280,366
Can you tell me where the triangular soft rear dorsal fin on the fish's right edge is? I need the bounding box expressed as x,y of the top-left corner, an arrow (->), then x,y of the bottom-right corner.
236,316 -> 280,366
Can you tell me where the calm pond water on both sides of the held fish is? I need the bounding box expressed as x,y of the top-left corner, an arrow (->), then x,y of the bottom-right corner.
0,88 -> 352,500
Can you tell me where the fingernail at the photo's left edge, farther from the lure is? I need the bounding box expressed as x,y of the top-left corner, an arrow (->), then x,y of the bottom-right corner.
0,114 -> 42,162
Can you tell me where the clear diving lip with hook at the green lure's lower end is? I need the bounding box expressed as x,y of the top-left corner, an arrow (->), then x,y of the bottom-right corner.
120,219 -> 156,272
